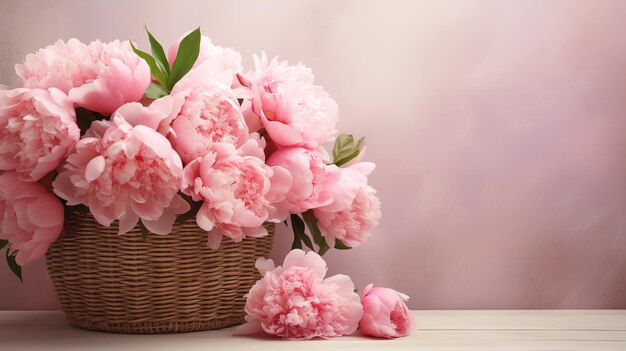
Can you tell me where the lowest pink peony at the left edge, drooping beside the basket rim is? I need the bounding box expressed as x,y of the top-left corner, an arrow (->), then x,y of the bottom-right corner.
0,172 -> 63,265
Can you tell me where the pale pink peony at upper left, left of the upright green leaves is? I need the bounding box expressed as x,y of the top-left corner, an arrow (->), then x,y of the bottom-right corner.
15,39 -> 151,114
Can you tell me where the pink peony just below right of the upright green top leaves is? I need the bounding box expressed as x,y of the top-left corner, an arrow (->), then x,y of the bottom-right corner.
169,83 -> 250,164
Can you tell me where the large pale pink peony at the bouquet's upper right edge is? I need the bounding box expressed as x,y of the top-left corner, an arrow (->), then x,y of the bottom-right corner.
250,54 -> 339,150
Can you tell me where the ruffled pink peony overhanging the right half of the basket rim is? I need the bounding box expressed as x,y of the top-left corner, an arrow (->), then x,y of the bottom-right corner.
182,138 -> 291,249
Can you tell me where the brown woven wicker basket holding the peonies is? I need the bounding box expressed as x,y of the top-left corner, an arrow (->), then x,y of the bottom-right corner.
46,215 -> 275,334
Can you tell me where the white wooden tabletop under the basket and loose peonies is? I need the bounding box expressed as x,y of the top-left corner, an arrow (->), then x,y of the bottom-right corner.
0,310 -> 626,351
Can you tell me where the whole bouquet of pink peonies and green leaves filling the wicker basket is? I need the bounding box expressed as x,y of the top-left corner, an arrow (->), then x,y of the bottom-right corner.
0,29 -> 381,279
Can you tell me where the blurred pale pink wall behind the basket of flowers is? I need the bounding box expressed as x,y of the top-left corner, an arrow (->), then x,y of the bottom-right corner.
0,0 -> 626,309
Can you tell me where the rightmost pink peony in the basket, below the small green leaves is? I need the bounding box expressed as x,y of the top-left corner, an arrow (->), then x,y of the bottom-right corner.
313,185 -> 382,247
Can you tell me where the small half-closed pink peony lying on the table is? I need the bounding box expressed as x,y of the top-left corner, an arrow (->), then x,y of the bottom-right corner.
359,284 -> 413,338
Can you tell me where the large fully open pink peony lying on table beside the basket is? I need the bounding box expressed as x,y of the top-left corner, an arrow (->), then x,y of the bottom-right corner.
236,250 -> 363,340
